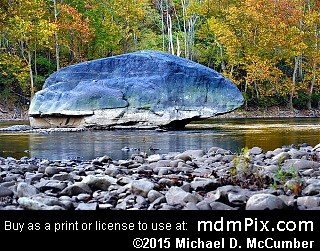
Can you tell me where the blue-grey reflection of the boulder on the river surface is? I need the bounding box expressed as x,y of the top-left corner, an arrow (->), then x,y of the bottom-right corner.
29,130 -> 243,159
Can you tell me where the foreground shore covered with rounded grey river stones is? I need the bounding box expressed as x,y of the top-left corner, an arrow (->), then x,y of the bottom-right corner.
0,144 -> 320,210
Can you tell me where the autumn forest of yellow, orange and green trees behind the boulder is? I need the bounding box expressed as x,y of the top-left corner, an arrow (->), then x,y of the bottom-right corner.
0,0 -> 320,118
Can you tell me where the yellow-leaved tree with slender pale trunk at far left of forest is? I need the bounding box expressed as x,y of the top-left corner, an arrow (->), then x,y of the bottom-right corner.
2,0 -> 55,97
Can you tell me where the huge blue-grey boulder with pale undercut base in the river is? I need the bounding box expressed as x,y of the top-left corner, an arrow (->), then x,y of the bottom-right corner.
29,50 -> 244,128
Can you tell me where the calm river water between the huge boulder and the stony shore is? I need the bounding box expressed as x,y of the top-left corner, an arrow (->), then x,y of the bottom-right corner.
0,118 -> 320,160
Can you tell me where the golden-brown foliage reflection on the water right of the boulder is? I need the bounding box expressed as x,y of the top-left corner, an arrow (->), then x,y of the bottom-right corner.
188,118 -> 320,151
